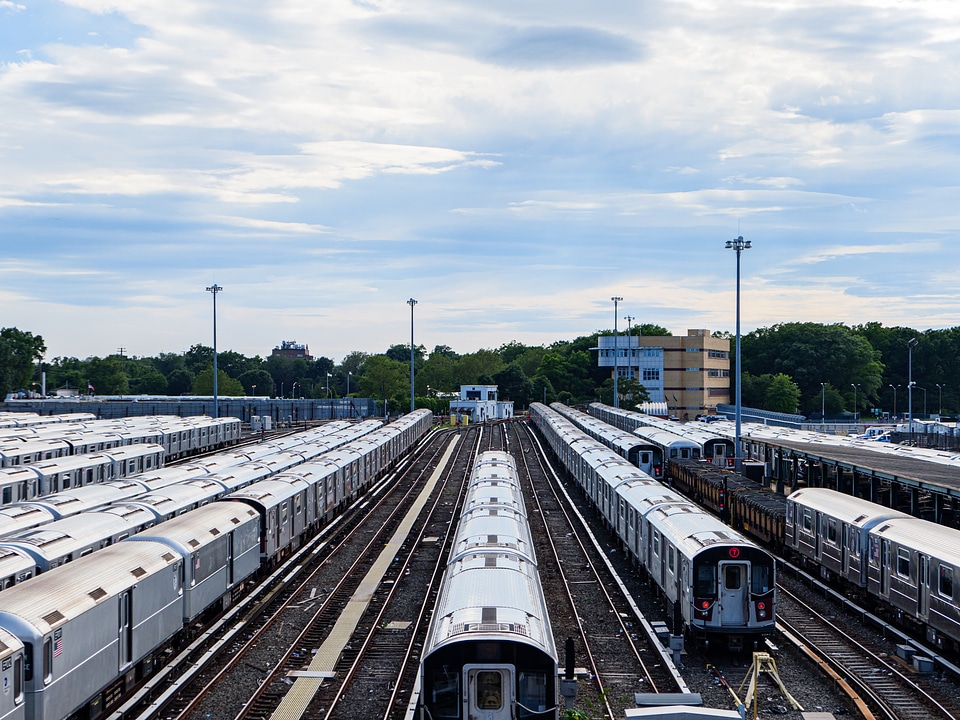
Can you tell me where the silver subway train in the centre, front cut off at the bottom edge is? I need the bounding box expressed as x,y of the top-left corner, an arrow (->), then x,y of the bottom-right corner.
420,451 -> 559,720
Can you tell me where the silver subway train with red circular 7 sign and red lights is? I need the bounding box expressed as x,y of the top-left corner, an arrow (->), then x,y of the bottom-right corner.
530,403 -> 776,650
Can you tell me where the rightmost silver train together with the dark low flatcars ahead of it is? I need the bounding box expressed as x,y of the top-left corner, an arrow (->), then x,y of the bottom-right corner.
670,461 -> 960,657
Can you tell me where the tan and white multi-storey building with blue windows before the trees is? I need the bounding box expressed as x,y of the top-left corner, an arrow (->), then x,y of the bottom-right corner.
593,329 -> 730,419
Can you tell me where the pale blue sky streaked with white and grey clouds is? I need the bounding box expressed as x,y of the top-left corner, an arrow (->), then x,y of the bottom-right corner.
0,0 -> 960,361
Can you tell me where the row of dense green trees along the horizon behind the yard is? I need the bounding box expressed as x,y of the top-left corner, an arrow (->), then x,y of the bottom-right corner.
0,323 -> 960,416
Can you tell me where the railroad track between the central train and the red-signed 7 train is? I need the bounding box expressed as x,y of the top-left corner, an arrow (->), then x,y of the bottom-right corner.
513,424 -> 686,718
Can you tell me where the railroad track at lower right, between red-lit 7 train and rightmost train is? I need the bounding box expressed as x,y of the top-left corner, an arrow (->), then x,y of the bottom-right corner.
777,583 -> 955,720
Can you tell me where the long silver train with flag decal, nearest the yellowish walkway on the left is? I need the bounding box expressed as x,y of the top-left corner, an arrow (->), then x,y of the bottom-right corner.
0,410 -> 433,720
